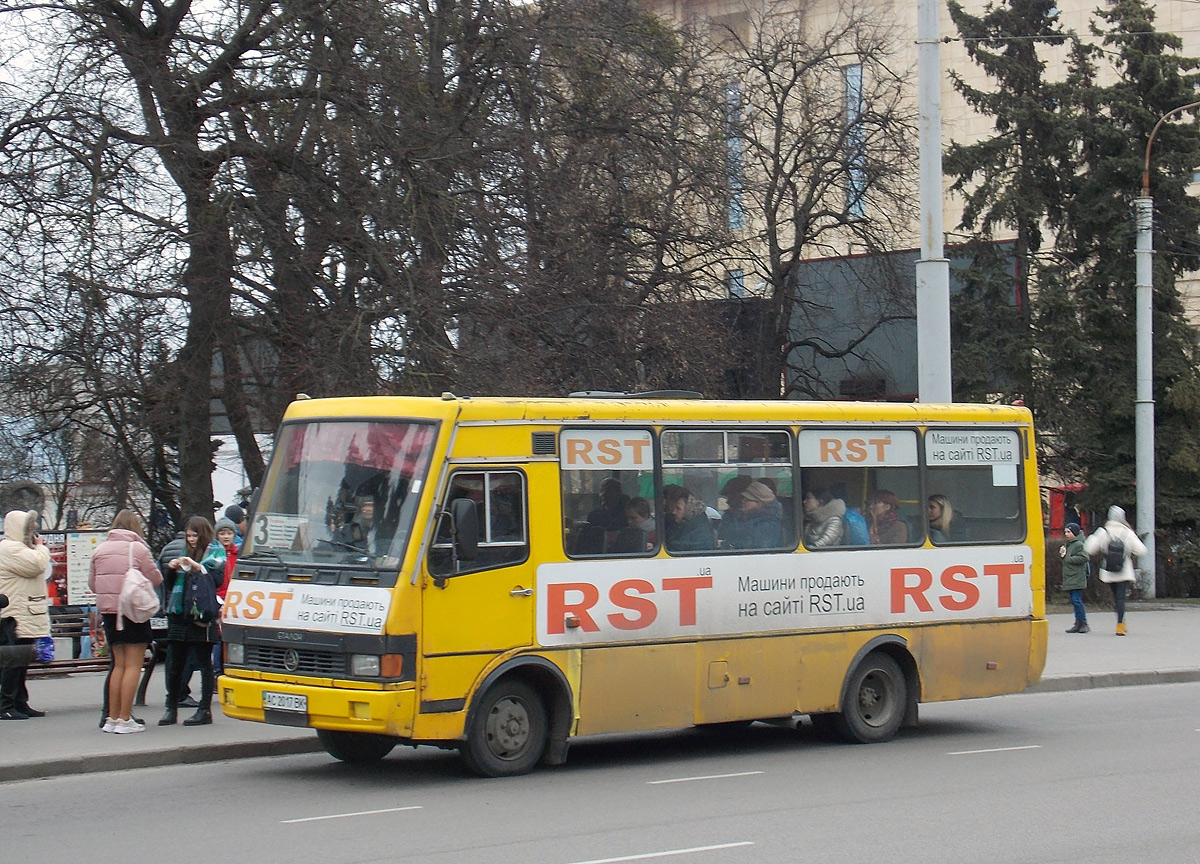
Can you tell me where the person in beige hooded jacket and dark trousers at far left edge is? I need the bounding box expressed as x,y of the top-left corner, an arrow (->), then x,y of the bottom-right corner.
0,510 -> 50,720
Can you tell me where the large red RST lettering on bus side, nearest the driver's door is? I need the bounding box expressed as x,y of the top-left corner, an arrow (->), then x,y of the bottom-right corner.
545,576 -> 713,636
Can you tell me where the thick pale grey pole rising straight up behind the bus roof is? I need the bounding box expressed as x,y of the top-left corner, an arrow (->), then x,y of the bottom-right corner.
917,0 -> 952,402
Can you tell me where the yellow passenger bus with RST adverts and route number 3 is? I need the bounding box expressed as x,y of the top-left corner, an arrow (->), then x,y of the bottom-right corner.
218,394 -> 1046,776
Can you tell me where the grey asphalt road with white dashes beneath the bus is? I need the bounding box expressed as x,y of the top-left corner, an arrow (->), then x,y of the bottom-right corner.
11,683 -> 1200,864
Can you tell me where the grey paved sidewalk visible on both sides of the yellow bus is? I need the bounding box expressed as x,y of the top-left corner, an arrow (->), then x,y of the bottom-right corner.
0,604 -> 1200,781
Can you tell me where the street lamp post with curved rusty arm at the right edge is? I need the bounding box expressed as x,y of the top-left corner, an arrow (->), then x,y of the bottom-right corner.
1134,102 -> 1200,599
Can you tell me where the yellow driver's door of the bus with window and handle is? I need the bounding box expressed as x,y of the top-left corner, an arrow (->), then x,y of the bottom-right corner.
421,466 -> 534,672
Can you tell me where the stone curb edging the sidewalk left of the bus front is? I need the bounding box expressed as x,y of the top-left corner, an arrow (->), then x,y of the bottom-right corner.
0,736 -> 324,782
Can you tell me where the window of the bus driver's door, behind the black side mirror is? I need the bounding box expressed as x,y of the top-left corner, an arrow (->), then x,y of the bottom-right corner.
428,470 -> 529,576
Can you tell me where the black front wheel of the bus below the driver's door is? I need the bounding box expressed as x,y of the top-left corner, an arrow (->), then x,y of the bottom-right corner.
460,678 -> 546,776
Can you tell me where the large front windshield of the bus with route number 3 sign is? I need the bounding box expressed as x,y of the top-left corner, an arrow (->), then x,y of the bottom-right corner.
242,420 -> 437,570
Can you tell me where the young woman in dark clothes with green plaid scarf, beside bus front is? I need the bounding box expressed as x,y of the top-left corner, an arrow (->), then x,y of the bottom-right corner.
158,516 -> 226,726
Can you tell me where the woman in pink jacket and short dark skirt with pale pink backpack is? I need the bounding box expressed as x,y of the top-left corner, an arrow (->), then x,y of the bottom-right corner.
88,510 -> 162,734
